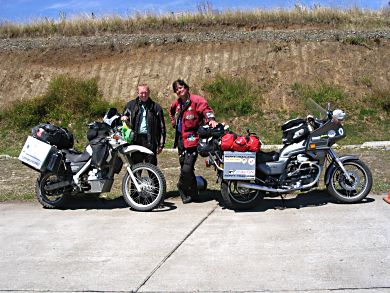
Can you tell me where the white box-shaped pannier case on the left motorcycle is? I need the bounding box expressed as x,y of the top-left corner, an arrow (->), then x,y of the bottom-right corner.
18,136 -> 58,171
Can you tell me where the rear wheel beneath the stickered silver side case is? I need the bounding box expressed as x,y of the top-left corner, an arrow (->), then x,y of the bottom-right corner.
221,181 -> 262,210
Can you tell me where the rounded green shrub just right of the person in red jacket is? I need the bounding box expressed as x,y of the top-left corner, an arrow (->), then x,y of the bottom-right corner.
202,76 -> 262,117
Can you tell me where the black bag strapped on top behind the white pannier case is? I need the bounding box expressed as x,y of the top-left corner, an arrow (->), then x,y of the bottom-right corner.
31,123 -> 74,149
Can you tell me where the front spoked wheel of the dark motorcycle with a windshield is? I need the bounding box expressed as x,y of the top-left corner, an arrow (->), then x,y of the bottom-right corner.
327,160 -> 372,203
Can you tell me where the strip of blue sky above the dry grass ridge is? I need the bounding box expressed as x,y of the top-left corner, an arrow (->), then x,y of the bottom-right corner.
0,0 -> 389,22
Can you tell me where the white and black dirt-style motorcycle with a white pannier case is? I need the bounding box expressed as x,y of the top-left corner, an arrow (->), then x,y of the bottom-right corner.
19,108 -> 166,211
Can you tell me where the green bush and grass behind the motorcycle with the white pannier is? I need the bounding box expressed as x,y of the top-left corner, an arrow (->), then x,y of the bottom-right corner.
0,75 -> 115,156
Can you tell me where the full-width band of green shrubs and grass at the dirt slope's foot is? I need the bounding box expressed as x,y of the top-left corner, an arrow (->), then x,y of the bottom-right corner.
0,75 -> 390,156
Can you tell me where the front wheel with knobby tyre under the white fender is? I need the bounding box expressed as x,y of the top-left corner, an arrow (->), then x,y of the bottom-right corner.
122,163 -> 166,212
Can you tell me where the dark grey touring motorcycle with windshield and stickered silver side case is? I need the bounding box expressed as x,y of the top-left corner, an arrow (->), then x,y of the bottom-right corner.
198,104 -> 373,209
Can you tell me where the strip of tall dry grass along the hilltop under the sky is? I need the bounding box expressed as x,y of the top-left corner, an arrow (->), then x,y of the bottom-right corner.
0,2 -> 390,38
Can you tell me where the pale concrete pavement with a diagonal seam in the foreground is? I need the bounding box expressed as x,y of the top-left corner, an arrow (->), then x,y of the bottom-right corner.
0,191 -> 390,292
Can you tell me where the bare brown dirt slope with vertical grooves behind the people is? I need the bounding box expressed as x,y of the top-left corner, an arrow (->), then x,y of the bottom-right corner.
0,32 -> 390,108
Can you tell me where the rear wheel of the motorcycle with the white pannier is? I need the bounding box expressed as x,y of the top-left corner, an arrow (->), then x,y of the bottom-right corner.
35,172 -> 69,209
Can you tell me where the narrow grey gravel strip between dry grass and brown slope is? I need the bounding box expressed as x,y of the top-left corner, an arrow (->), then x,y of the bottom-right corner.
0,29 -> 390,51
